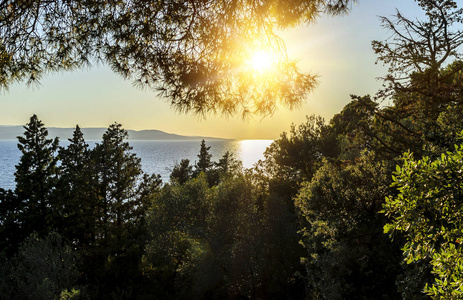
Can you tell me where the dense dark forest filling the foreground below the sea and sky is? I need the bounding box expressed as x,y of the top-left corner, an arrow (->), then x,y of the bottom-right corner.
0,0 -> 463,299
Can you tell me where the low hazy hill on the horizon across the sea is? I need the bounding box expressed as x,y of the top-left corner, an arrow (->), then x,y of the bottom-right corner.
0,125 -> 225,141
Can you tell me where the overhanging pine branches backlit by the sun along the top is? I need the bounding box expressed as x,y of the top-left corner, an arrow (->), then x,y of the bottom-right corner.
0,0 -> 353,114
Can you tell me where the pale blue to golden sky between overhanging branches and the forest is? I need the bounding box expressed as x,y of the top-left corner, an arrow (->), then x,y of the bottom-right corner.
0,0 -> 422,139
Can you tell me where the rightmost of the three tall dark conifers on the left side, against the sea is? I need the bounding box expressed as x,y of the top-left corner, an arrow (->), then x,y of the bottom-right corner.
84,123 -> 161,298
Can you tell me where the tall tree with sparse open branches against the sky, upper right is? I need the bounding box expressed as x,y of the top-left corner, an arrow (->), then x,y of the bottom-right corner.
372,0 -> 463,158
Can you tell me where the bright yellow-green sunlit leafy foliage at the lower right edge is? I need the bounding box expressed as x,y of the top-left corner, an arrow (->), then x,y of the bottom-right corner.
384,146 -> 463,299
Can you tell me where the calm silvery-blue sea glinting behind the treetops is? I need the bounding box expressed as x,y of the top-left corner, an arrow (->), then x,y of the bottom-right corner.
0,140 -> 272,189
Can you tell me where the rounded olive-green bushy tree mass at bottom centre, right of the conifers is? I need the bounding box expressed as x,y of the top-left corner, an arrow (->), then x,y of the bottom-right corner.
144,166 -> 303,298
